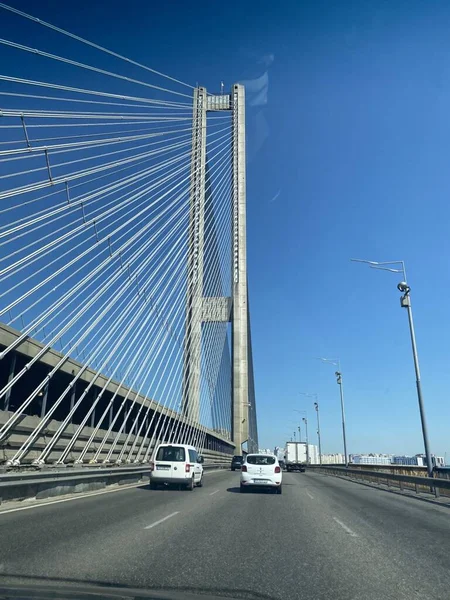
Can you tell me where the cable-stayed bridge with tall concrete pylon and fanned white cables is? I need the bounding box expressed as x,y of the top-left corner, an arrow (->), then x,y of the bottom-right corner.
0,6 -> 258,466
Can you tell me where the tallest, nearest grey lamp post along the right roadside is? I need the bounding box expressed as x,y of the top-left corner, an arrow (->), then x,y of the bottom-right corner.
351,258 -> 433,477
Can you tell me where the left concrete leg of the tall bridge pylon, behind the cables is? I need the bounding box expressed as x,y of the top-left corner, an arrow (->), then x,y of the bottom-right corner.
183,88 -> 207,423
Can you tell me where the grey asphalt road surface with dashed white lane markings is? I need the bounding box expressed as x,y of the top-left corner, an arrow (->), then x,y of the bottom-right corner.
0,471 -> 450,600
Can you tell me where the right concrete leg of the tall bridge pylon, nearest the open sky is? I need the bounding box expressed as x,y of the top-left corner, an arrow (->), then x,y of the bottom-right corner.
231,84 -> 249,454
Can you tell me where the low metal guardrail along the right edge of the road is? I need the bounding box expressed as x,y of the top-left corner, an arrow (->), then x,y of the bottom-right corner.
308,465 -> 450,498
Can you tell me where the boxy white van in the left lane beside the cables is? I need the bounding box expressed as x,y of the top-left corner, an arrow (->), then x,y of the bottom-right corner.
150,444 -> 203,490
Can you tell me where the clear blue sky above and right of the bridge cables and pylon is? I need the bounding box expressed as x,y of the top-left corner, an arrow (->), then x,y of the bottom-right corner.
5,0 -> 450,455
